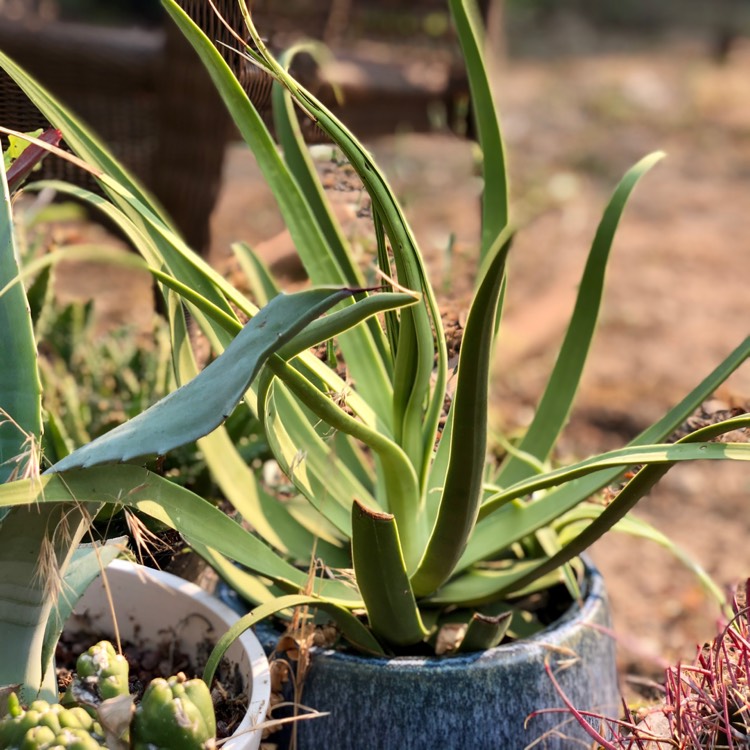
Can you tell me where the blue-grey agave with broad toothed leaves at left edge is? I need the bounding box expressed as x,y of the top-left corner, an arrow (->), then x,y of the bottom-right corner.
0,129 -> 414,703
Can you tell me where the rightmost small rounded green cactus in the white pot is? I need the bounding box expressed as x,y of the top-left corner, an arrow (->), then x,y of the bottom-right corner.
131,672 -> 216,750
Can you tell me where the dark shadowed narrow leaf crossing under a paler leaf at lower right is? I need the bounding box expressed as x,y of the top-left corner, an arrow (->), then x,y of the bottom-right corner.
502,418 -> 750,588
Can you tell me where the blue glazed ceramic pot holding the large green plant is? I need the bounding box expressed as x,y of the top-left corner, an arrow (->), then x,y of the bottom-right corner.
217,568 -> 620,750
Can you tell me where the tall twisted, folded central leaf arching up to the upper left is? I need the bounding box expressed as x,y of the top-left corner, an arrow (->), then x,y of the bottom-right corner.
232,0 -> 447,500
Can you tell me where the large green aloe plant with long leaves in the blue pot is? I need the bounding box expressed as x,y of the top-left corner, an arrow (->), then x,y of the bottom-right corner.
165,0 -> 750,651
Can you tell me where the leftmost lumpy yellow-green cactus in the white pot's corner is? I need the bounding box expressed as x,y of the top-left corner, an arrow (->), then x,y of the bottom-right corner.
0,693 -> 105,750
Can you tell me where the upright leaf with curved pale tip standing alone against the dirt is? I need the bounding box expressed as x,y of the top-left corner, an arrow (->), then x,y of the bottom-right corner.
497,152 -> 664,486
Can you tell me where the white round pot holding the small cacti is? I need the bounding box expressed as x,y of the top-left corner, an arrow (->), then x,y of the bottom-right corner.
68,560 -> 271,750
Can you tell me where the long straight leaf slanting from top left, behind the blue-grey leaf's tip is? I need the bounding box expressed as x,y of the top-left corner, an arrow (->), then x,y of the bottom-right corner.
163,0 -> 396,420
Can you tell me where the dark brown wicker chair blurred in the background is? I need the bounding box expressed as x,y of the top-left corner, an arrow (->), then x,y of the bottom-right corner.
0,0 -> 482,252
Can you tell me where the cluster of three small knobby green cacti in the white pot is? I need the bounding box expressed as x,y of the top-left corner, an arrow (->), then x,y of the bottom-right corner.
0,641 -> 216,750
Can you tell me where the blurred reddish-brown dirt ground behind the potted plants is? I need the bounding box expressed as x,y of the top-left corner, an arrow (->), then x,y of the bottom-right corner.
54,26 -> 750,704
